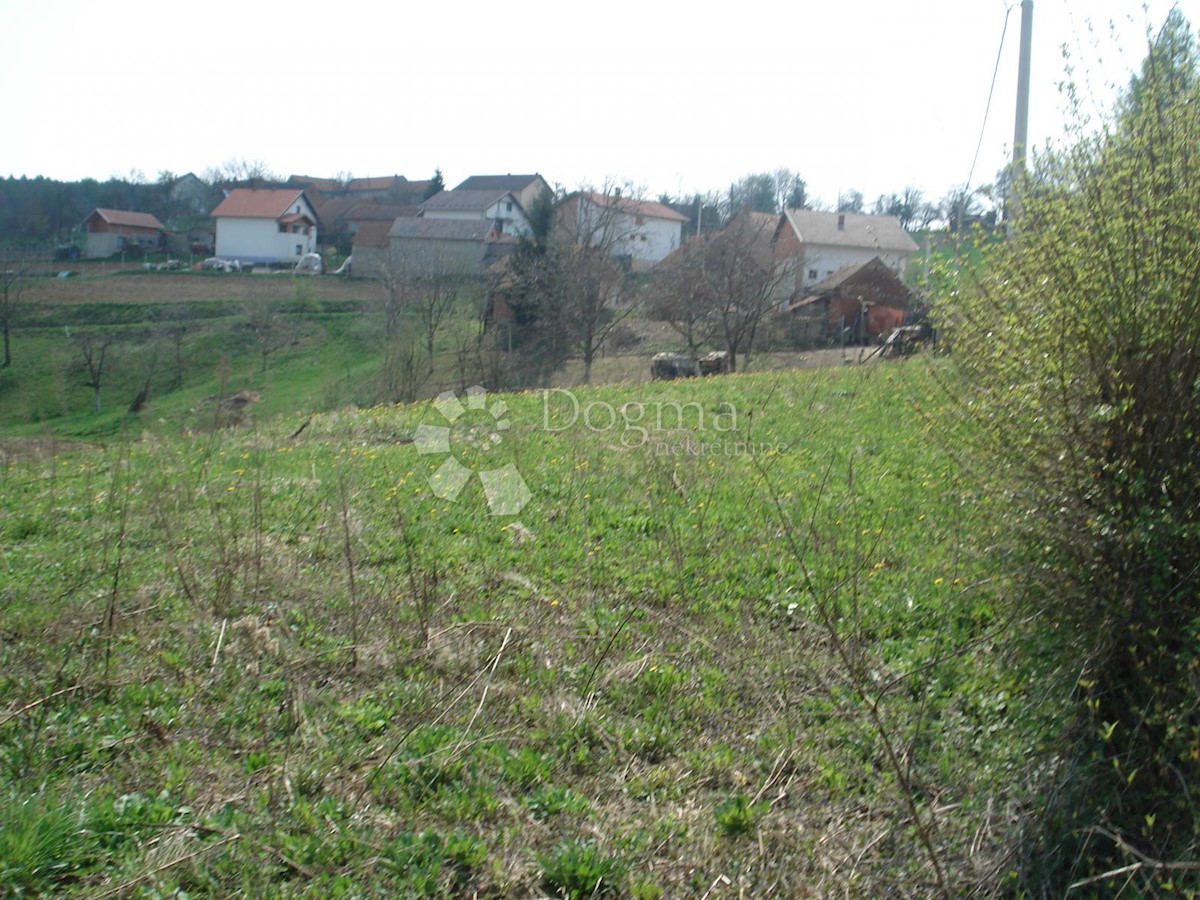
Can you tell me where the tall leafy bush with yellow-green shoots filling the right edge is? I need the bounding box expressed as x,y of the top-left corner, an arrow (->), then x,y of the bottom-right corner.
943,11 -> 1200,896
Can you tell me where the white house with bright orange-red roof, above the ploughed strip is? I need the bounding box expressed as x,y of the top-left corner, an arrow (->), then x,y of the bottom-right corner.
212,187 -> 318,264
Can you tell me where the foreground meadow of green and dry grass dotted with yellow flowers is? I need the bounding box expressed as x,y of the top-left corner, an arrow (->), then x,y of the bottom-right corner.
0,355 -> 1057,898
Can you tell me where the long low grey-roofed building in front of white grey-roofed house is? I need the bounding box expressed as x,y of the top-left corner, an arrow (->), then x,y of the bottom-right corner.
353,217 -> 517,277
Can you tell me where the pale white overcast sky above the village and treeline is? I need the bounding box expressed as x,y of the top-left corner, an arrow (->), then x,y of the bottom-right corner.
0,0 -> 1200,204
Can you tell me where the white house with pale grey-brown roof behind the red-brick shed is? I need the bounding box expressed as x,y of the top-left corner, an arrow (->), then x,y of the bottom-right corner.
774,209 -> 917,298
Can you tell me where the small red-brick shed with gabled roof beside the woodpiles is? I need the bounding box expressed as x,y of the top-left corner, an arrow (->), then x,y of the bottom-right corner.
787,257 -> 911,344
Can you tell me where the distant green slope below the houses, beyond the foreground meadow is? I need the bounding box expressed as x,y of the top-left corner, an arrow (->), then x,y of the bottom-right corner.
0,271 -> 883,444
